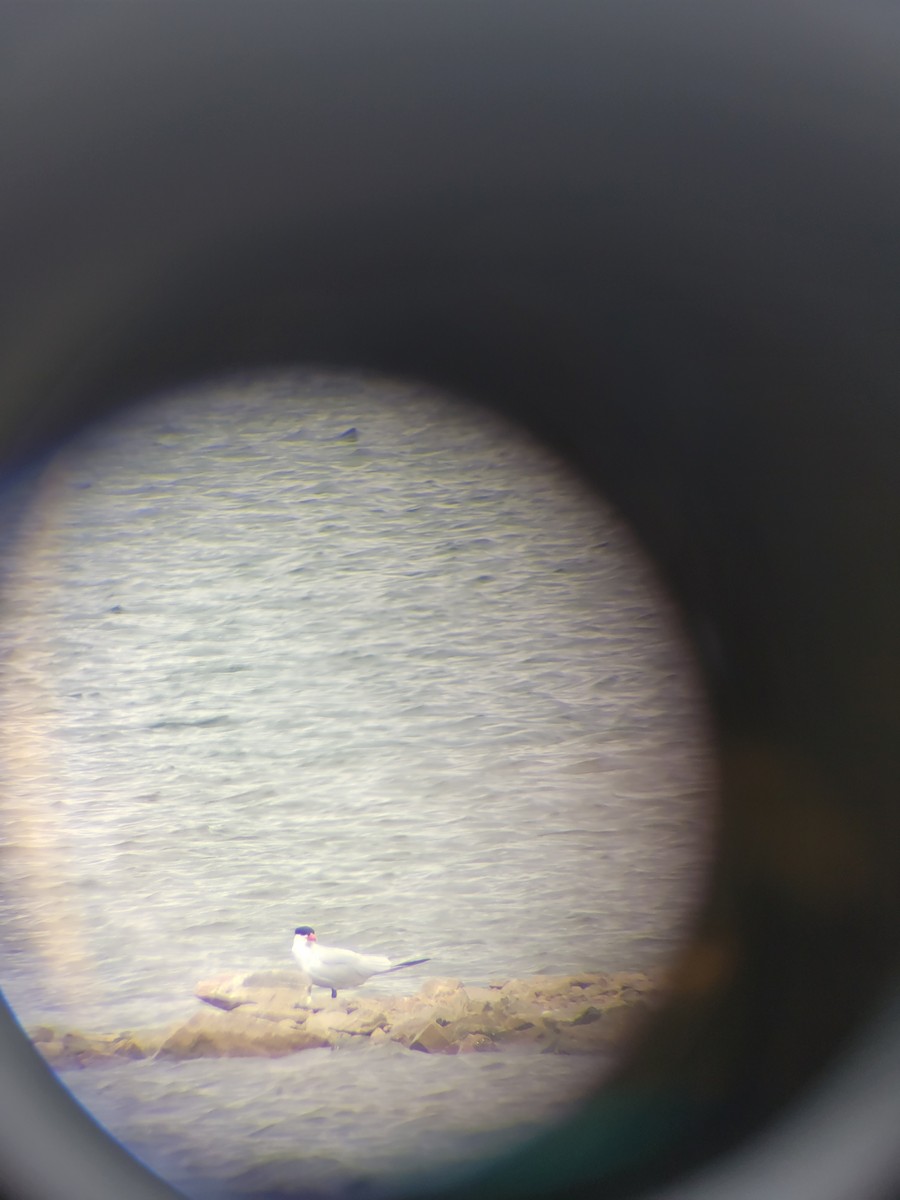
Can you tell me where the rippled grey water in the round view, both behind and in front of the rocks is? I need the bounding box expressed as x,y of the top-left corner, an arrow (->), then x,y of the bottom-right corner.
0,372 -> 712,1196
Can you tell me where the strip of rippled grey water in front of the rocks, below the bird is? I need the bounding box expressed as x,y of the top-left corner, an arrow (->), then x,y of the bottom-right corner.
58,1044 -> 607,1200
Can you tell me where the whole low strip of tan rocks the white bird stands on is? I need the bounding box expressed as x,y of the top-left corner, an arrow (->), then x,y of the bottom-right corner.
28,971 -> 661,1069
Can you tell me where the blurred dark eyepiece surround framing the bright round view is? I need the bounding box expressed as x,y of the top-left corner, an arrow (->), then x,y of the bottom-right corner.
0,7 -> 900,1200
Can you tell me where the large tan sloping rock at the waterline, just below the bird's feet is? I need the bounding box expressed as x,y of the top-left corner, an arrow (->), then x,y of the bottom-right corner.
157,1012 -> 329,1058
